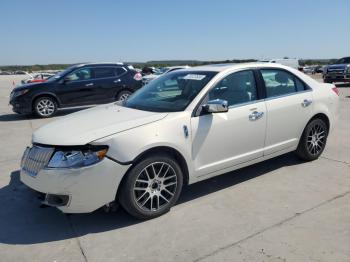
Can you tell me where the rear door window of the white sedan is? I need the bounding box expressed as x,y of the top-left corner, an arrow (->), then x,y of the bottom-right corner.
260,69 -> 305,97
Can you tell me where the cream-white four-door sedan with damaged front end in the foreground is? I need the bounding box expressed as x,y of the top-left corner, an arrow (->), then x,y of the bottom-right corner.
20,63 -> 339,219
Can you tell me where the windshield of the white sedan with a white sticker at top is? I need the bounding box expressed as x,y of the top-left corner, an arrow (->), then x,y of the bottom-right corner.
123,70 -> 217,112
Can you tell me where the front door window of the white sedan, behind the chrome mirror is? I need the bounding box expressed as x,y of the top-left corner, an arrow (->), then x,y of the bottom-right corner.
208,70 -> 257,106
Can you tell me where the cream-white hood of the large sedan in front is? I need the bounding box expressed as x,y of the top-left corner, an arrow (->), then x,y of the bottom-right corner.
33,103 -> 167,146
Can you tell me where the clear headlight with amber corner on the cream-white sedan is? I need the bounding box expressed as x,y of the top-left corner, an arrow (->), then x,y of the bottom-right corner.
48,147 -> 108,168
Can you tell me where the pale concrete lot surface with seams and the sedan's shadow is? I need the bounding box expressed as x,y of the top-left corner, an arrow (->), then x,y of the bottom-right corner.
0,73 -> 350,262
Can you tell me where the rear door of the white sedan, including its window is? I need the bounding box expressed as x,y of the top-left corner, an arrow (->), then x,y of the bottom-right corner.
260,69 -> 313,155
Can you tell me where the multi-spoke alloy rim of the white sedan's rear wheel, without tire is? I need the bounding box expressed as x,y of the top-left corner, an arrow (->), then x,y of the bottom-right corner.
307,124 -> 327,155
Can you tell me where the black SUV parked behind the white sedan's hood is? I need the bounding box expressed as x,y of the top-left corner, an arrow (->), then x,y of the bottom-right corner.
10,63 -> 142,117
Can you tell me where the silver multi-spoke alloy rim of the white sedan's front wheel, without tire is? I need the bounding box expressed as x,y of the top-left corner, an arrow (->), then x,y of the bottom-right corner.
133,162 -> 178,212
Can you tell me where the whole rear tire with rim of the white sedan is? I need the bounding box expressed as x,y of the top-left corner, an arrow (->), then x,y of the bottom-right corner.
296,118 -> 328,161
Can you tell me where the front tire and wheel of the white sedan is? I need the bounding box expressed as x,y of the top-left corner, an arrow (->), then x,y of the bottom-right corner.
119,154 -> 183,220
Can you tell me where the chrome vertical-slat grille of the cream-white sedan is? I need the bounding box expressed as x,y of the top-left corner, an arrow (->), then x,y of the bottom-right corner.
21,146 -> 54,177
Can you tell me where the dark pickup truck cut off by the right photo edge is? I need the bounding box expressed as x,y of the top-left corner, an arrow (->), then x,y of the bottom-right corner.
323,57 -> 350,83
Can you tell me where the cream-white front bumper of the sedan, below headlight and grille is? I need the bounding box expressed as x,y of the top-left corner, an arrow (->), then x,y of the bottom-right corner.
20,158 -> 130,213
